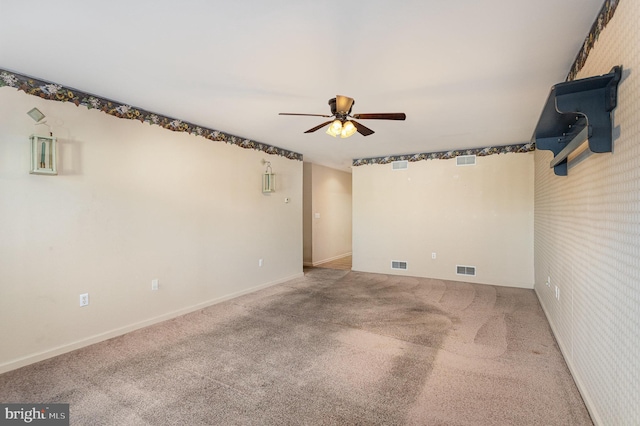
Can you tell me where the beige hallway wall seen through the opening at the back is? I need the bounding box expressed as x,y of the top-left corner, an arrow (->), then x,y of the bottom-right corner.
304,163 -> 352,265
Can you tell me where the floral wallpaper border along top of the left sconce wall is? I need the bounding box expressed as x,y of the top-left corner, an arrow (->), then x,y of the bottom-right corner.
0,68 -> 302,161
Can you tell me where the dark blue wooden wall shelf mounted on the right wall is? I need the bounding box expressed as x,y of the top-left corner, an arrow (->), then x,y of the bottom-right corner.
531,66 -> 622,176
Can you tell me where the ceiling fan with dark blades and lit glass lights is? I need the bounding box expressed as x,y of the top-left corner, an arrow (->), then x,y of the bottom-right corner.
279,95 -> 407,138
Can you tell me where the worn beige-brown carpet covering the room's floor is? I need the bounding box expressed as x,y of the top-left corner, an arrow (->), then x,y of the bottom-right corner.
0,268 -> 592,426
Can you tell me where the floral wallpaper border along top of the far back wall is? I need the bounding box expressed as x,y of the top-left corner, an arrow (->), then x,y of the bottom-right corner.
353,142 -> 535,166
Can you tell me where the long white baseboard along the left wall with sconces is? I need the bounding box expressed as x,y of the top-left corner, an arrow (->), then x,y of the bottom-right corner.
0,272 -> 304,374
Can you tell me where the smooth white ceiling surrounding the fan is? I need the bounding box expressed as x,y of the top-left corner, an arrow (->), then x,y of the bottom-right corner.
0,0 -> 603,171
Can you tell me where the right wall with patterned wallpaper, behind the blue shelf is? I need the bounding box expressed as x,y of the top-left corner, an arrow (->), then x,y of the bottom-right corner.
535,0 -> 640,425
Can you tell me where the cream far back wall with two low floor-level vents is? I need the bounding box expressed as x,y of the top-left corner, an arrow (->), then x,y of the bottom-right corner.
353,152 -> 533,288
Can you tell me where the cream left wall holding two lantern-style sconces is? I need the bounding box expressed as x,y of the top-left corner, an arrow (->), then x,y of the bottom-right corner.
0,87 -> 302,372
